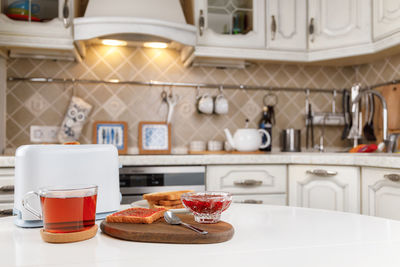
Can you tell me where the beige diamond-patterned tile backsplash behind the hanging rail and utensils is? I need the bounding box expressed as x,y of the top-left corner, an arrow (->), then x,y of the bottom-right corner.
7,46 -> 358,152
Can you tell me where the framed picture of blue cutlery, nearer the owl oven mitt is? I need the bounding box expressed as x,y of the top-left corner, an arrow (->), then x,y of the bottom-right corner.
93,121 -> 128,154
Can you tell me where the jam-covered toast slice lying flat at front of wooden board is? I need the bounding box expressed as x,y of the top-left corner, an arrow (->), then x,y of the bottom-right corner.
106,208 -> 167,223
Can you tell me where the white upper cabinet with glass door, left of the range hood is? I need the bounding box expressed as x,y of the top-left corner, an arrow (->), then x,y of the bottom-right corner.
0,0 -> 79,61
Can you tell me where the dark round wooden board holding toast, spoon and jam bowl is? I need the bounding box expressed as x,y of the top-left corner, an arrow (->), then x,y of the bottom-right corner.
100,214 -> 235,244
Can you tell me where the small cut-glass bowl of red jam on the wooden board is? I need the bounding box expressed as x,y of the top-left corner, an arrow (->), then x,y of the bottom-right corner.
181,192 -> 232,223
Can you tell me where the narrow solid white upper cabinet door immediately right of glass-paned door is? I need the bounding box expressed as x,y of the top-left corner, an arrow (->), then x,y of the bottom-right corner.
266,0 -> 307,51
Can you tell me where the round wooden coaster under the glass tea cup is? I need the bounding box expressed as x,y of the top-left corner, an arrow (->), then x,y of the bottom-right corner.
40,224 -> 99,243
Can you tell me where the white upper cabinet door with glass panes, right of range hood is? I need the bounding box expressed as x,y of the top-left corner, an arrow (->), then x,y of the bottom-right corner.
195,0 -> 265,48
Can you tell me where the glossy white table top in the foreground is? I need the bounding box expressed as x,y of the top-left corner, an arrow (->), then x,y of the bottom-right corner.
0,204 -> 400,267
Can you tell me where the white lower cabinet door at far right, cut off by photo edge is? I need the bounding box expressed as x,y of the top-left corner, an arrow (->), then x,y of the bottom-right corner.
361,167 -> 400,220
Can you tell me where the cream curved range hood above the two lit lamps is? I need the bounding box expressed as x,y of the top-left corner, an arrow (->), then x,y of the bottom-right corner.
74,0 -> 196,46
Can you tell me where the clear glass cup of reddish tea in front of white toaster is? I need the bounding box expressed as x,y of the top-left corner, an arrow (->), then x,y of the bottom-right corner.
22,185 -> 98,233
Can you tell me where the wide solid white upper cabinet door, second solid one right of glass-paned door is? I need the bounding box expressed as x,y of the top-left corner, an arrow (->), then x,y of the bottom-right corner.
308,0 -> 372,50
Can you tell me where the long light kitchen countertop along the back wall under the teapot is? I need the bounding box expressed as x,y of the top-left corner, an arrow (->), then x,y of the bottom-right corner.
0,152 -> 400,168
